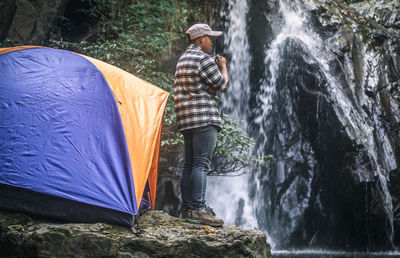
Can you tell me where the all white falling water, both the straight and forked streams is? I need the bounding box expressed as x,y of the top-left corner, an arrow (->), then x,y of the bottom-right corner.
207,0 -> 395,249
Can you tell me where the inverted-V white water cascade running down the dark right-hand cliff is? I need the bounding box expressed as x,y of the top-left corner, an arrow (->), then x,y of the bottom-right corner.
254,0 -> 394,248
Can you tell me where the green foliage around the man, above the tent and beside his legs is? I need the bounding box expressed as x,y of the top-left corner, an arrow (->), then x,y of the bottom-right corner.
49,0 -> 270,174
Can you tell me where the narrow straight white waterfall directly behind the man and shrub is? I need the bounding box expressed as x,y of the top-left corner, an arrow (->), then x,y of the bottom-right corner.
206,0 -> 257,234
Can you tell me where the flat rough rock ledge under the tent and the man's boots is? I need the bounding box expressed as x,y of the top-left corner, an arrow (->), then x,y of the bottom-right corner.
0,211 -> 271,257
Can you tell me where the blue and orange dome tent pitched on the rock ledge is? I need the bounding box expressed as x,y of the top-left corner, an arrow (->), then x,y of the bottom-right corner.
0,46 -> 168,226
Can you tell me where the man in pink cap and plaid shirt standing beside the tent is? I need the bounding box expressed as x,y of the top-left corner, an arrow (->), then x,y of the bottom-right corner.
174,24 -> 229,226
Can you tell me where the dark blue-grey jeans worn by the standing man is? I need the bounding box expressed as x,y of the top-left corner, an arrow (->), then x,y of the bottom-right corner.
180,125 -> 218,210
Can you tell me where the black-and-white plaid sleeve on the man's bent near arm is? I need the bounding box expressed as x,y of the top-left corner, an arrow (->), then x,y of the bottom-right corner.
199,55 -> 227,91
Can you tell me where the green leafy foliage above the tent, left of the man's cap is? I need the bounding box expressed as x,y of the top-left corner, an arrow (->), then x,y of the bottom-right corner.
51,0 -> 188,75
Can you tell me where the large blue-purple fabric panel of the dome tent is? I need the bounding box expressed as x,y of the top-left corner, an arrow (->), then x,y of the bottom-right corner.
0,48 -> 138,214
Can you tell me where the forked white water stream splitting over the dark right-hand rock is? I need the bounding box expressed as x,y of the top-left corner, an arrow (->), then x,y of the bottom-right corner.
255,0 -> 395,248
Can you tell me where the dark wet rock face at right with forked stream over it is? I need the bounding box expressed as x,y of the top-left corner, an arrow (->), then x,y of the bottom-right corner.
230,0 -> 400,251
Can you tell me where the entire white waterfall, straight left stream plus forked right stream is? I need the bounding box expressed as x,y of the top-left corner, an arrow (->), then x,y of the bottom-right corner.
207,0 -> 395,252
